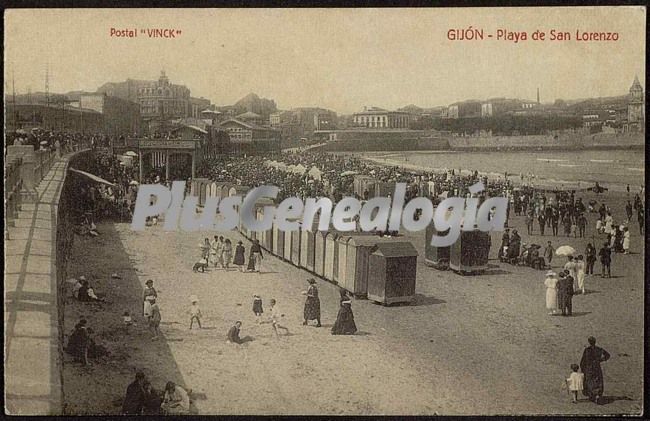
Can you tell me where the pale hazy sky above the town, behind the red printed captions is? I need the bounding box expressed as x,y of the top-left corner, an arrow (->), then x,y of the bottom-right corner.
4,6 -> 646,114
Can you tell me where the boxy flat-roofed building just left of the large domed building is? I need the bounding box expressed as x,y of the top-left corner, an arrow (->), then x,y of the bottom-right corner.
79,94 -> 142,136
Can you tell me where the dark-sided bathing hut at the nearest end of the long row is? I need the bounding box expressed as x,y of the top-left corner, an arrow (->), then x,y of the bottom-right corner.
368,241 -> 418,304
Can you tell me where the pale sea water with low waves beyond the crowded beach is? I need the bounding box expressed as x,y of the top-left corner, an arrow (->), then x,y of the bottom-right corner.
353,150 -> 645,191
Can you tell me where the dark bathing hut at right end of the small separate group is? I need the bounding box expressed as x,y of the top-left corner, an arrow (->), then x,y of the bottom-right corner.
449,230 -> 491,275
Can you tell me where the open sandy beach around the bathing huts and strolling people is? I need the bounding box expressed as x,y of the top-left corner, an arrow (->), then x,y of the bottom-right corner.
64,189 -> 643,415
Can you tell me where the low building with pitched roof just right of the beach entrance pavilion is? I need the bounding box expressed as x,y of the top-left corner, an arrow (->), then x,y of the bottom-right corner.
219,119 -> 281,155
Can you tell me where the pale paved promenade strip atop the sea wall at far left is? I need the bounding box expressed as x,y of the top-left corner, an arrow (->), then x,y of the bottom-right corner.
4,155 -> 70,415
